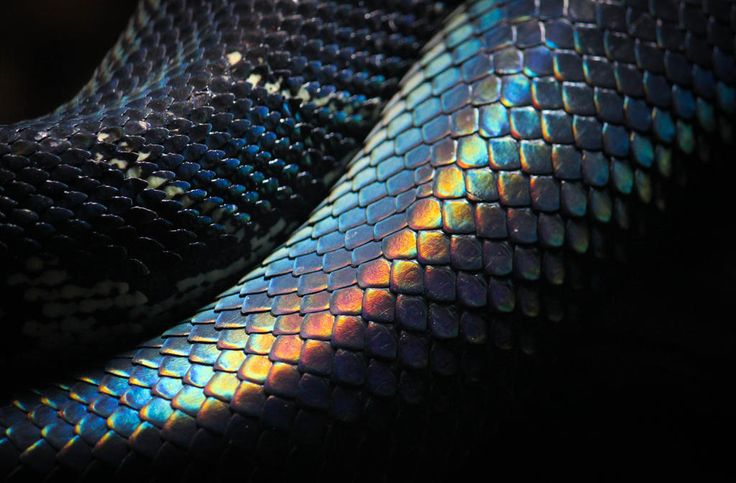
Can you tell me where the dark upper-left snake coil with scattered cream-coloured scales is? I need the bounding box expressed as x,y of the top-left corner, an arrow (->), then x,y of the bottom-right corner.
0,0 -> 446,367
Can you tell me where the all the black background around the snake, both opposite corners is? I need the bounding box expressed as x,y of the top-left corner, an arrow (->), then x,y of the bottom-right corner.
0,0 -> 736,479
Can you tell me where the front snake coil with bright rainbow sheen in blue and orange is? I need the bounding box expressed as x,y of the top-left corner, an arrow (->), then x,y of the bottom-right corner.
0,0 -> 736,482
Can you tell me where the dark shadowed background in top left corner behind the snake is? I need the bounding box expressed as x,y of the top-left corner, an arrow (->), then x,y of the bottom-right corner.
0,0 -> 138,124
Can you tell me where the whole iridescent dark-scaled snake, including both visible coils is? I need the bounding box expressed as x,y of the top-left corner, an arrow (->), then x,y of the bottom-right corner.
0,0 -> 736,481
